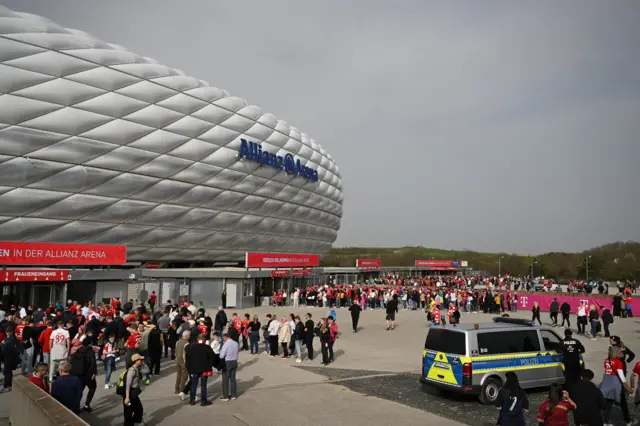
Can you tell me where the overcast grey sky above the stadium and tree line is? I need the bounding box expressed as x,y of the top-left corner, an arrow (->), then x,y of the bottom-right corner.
6,0 -> 640,254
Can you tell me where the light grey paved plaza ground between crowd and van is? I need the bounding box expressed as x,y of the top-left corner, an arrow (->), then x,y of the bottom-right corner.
0,307 -> 640,426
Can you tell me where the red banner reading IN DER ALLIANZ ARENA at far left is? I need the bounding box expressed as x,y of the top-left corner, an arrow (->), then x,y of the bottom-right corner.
0,242 -> 127,265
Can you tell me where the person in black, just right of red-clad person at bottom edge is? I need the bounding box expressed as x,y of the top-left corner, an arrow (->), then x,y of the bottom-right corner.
569,370 -> 606,426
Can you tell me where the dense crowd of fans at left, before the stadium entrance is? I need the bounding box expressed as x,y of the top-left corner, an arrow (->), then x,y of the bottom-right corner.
0,295 -> 339,425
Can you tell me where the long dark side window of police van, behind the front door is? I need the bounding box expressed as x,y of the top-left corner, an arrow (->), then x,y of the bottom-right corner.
478,330 -> 540,356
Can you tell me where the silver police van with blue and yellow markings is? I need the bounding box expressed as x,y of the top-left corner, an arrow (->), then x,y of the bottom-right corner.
421,318 -> 564,404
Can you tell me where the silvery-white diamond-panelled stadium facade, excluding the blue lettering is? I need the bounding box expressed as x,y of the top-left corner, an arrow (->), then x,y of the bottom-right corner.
0,6 -> 343,262
